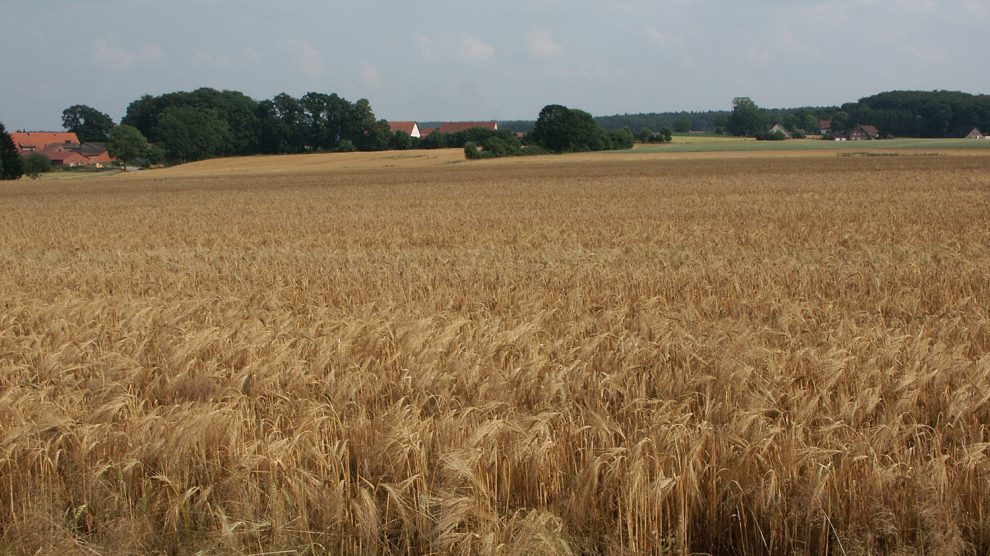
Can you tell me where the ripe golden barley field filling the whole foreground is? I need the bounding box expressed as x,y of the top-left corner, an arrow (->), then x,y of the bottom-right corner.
0,151 -> 990,555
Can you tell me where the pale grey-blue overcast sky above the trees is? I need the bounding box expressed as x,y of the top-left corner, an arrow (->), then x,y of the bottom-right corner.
0,0 -> 990,130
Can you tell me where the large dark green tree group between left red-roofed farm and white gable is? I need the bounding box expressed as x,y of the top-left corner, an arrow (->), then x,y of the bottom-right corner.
56,88 -> 398,163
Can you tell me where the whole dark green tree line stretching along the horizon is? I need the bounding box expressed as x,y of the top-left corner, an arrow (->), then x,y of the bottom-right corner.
25,88 -> 990,175
